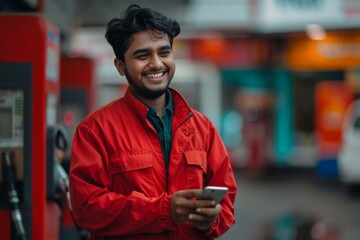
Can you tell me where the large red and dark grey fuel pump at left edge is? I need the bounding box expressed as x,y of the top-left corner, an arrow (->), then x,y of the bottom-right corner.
0,14 -> 61,240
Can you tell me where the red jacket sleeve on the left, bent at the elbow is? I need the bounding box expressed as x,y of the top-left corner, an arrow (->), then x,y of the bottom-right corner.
69,124 -> 175,236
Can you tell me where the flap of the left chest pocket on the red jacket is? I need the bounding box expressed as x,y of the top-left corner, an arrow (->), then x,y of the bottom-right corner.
109,151 -> 153,174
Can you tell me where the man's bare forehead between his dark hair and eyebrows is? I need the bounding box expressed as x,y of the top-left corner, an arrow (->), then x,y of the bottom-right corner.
128,31 -> 170,52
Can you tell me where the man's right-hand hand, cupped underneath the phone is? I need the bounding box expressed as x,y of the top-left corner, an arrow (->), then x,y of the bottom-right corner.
189,204 -> 222,230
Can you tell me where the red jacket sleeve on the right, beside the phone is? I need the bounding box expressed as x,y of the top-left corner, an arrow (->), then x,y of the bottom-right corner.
204,122 -> 237,238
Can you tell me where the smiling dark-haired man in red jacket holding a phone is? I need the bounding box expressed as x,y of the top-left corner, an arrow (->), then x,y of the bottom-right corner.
70,5 -> 237,240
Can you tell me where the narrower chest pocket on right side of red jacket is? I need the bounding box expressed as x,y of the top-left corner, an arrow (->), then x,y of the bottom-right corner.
185,150 -> 207,189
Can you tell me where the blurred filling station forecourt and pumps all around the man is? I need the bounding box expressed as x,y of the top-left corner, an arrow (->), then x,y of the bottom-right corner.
0,0 -> 360,240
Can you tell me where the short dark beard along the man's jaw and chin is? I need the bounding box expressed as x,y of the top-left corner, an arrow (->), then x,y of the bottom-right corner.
125,68 -> 172,100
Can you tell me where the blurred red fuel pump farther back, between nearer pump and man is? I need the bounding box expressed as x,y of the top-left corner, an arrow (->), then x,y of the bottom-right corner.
59,56 -> 95,240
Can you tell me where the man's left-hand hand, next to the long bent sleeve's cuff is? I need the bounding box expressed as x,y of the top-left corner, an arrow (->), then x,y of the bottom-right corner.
170,189 -> 215,223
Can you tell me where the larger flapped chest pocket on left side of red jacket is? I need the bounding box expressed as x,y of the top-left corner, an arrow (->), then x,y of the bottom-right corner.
109,151 -> 153,196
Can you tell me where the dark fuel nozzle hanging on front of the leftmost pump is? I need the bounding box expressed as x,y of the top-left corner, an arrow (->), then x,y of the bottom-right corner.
1,151 -> 26,240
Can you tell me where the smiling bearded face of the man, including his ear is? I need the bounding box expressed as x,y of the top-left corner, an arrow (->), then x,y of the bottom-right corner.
115,31 -> 175,100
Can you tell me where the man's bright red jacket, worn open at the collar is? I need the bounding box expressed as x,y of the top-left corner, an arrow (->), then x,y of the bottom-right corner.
70,89 -> 237,240
